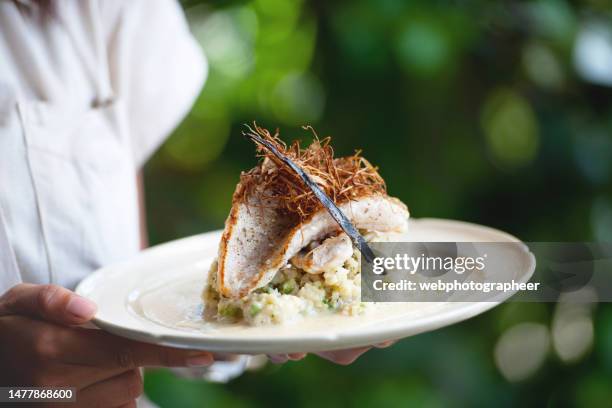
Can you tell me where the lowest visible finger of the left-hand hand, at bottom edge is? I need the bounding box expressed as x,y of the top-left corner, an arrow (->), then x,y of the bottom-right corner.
77,370 -> 143,407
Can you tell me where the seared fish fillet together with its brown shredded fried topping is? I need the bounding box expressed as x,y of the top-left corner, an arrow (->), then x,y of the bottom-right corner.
217,124 -> 408,298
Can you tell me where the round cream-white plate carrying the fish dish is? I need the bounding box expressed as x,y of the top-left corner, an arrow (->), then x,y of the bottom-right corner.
76,219 -> 535,353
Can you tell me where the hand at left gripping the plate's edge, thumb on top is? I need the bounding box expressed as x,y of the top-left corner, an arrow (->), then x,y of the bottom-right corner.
0,284 -> 213,407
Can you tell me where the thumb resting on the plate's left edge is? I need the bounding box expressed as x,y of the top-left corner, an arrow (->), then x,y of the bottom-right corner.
0,283 -> 97,325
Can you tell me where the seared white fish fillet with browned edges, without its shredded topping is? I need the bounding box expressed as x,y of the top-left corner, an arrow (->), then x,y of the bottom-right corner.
217,193 -> 408,298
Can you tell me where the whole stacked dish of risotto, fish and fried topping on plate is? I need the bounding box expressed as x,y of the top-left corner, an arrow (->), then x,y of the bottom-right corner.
202,125 -> 409,326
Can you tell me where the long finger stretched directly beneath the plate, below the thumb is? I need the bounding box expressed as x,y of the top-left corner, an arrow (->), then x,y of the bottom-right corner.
57,328 -> 214,371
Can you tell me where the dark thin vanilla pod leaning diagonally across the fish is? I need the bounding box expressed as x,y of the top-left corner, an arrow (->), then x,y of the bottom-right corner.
242,126 -> 376,264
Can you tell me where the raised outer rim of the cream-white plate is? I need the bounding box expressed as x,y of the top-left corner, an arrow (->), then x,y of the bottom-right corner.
75,218 -> 536,354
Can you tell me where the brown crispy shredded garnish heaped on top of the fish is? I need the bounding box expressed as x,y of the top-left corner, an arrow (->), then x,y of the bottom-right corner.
239,123 -> 386,219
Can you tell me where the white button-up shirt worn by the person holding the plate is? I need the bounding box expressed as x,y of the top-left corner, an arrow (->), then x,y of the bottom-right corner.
0,0 -> 206,294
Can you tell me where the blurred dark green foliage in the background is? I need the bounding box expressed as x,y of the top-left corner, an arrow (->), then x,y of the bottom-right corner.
146,0 -> 612,407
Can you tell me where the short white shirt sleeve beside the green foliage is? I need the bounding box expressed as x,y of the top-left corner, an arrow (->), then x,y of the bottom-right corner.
105,0 -> 208,167
